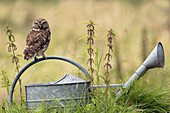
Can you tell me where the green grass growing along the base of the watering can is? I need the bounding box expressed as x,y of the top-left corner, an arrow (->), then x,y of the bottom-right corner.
1,70 -> 170,113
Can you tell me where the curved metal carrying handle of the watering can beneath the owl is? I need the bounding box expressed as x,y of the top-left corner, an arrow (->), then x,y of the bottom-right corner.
9,56 -> 91,107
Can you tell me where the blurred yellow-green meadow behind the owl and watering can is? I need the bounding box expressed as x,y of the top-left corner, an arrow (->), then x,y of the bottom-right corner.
0,0 -> 170,112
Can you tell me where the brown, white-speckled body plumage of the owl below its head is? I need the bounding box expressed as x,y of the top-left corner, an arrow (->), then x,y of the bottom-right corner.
23,29 -> 51,60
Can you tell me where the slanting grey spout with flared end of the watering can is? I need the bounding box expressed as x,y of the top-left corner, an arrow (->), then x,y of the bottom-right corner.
116,42 -> 165,96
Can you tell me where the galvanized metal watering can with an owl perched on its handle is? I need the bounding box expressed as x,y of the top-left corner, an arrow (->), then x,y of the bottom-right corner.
9,42 -> 165,109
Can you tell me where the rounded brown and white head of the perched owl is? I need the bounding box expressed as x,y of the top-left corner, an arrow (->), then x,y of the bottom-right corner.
32,18 -> 49,31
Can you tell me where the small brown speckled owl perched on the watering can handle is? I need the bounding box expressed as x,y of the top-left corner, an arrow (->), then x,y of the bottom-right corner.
23,18 -> 51,61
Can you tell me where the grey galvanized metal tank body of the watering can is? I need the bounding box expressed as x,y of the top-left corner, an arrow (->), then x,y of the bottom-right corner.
25,74 -> 90,109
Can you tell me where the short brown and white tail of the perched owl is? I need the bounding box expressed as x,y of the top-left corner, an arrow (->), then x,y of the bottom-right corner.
23,47 -> 35,61
